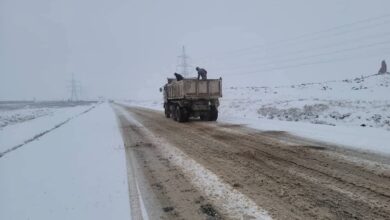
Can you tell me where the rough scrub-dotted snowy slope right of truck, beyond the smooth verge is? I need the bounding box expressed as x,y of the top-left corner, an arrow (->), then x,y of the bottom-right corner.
221,74 -> 390,131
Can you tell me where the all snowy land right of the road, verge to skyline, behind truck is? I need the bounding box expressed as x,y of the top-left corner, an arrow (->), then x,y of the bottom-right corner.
122,74 -> 390,155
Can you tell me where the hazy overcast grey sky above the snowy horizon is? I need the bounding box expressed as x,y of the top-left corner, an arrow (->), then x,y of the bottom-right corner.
0,0 -> 390,100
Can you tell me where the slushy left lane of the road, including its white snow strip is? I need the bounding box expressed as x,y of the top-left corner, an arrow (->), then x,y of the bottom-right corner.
114,105 -> 271,220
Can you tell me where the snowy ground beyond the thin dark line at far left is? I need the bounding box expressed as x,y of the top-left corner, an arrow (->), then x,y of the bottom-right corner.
0,105 -> 91,153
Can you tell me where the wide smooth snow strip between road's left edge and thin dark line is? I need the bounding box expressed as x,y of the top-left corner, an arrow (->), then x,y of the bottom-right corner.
0,104 -> 130,219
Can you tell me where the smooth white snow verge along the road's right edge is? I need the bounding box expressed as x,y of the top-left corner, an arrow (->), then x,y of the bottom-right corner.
218,115 -> 390,156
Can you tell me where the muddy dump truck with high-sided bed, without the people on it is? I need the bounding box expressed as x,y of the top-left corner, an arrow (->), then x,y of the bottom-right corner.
160,78 -> 222,122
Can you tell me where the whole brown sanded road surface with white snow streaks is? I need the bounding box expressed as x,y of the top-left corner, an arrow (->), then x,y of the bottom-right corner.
113,104 -> 390,219
